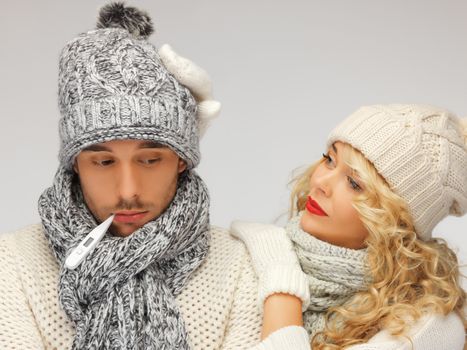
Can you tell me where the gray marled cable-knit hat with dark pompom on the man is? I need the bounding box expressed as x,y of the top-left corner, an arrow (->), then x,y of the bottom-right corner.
58,3 -> 200,169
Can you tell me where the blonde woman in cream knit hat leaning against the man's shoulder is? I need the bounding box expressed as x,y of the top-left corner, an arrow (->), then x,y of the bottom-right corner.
232,105 -> 467,350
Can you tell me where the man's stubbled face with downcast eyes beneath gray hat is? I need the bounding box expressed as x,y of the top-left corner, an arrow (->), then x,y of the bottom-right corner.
74,140 -> 186,236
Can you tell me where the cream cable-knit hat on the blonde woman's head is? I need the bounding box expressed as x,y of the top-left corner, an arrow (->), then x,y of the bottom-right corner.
328,105 -> 467,240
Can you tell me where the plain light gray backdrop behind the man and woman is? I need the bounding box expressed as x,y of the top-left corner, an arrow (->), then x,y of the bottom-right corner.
0,0 -> 467,278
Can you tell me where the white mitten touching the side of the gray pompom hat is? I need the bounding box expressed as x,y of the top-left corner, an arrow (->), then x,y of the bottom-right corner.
159,44 -> 221,137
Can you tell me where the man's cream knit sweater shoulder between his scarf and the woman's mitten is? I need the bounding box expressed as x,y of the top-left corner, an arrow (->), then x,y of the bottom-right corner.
177,226 -> 261,349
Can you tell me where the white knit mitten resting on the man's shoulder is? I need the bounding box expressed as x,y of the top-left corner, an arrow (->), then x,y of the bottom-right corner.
230,221 -> 310,311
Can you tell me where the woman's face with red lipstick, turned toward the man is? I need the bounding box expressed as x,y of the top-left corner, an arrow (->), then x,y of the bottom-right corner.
301,142 -> 368,249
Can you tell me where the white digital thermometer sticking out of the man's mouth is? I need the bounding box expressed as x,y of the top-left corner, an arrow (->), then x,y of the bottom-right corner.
65,214 -> 115,270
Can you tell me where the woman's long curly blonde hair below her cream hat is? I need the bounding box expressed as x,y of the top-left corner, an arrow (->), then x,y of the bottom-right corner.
290,144 -> 467,349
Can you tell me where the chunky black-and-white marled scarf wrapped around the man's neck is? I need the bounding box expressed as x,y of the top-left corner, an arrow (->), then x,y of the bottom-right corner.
39,167 -> 210,349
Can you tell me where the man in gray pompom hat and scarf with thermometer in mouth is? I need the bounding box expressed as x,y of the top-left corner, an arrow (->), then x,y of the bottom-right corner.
0,3 -> 261,349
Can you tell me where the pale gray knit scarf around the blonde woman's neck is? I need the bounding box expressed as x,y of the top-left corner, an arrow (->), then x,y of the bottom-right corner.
286,213 -> 367,337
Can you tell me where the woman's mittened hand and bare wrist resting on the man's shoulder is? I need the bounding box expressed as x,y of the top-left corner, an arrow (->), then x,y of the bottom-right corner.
230,221 -> 310,338
